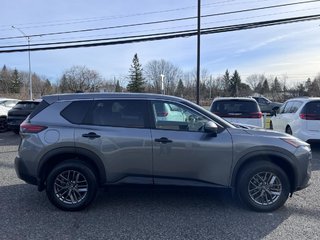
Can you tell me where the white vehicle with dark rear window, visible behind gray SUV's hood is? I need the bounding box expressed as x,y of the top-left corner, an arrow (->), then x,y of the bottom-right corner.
210,97 -> 263,127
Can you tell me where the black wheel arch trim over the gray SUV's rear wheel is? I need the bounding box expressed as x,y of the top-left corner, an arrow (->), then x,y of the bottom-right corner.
37,147 -> 107,191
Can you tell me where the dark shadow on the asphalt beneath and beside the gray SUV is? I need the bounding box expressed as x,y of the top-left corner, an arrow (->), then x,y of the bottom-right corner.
0,184 -> 296,239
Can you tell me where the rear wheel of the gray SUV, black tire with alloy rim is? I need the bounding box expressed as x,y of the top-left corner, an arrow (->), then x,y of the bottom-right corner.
46,160 -> 98,211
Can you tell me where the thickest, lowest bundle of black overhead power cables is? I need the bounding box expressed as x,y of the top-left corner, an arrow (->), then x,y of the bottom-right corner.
0,14 -> 320,53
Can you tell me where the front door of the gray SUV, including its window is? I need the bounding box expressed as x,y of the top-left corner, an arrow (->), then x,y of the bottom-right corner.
151,100 -> 232,186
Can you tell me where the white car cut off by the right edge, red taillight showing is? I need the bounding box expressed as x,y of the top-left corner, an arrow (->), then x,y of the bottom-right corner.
270,98 -> 320,142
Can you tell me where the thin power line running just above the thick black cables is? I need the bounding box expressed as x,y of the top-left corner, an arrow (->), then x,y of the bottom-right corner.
0,0 -> 320,40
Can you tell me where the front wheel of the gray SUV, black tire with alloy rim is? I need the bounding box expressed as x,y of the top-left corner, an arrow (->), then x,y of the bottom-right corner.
237,161 -> 290,212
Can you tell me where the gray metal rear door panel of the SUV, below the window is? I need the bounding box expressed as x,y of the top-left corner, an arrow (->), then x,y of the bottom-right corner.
75,127 -> 153,184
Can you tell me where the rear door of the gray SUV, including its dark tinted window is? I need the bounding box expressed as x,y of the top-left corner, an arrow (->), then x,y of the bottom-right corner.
65,99 -> 153,184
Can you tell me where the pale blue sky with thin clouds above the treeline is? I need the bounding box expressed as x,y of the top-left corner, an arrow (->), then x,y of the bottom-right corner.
0,0 -> 320,85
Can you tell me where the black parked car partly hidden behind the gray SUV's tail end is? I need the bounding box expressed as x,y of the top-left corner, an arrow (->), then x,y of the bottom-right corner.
7,100 -> 40,134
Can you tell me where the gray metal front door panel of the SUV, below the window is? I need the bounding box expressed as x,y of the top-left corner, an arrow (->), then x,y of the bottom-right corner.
152,130 -> 232,185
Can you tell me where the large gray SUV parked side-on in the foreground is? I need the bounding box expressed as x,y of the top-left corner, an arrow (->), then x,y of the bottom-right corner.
15,93 -> 311,211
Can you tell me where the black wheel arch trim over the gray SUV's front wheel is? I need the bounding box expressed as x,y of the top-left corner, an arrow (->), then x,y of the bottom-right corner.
231,151 -> 298,193
